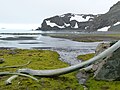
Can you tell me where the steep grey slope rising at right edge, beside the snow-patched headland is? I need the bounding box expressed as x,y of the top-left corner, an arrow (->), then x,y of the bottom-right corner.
89,2 -> 120,31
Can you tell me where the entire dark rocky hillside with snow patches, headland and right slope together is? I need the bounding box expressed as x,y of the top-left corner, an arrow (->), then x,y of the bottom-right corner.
37,1 -> 120,31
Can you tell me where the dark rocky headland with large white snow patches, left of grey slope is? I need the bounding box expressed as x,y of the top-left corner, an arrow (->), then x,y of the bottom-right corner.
37,13 -> 97,30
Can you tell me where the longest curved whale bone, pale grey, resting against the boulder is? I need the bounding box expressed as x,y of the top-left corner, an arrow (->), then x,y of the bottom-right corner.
18,40 -> 120,76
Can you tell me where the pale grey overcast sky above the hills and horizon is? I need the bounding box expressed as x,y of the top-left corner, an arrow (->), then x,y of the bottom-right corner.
0,0 -> 119,24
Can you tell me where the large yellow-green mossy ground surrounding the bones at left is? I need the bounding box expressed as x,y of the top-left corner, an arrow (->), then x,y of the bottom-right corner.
0,49 -> 83,90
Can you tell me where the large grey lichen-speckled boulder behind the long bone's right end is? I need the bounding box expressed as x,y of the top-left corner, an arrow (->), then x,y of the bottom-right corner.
93,41 -> 120,81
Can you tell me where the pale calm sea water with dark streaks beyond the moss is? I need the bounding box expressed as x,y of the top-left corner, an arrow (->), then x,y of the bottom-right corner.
0,29 -> 98,49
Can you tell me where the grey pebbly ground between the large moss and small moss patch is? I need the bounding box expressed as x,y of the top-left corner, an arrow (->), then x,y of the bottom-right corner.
52,48 -> 94,65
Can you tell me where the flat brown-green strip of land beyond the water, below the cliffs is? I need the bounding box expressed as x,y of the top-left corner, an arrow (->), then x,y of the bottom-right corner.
46,33 -> 120,42
